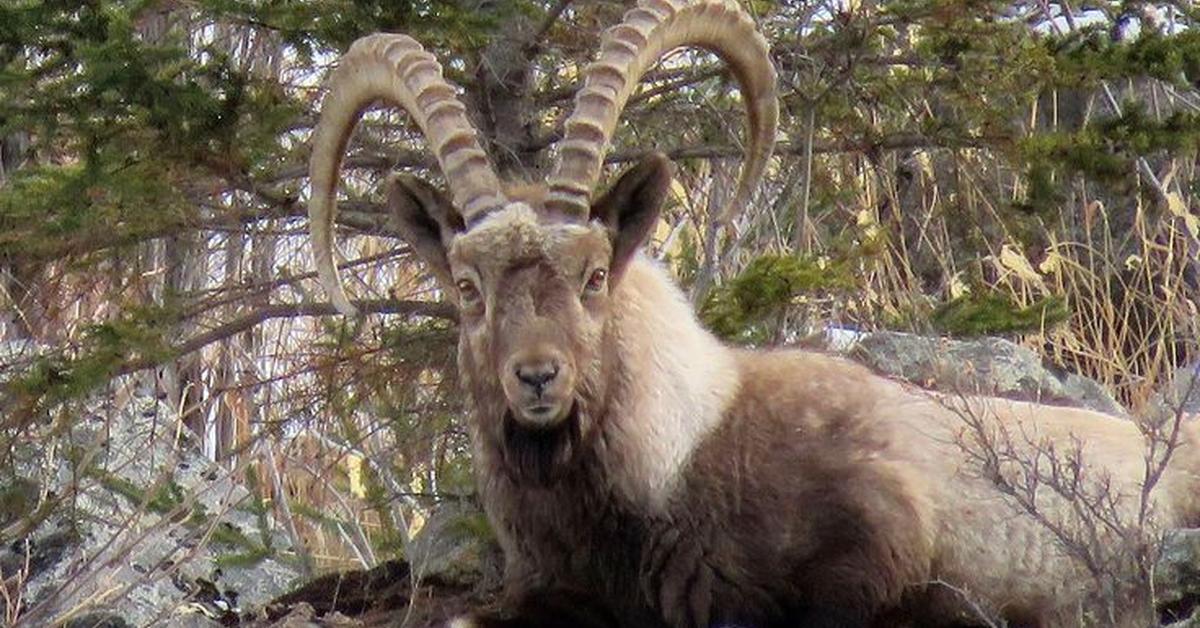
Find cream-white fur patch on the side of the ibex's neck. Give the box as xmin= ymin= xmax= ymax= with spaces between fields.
xmin=601 ymin=256 xmax=738 ymax=510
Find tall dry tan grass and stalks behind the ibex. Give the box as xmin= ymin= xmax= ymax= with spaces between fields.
xmin=0 ymin=2 xmax=1200 ymax=624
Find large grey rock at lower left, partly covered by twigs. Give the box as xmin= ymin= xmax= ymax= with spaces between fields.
xmin=8 ymin=374 xmax=300 ymax=628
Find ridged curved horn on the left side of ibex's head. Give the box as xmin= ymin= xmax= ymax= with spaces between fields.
xmin=308 ymin=35 xmax=504 ymax=316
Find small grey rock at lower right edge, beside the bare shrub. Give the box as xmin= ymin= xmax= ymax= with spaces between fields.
xmin=1154 ymin=528 xmax=1200 ymax=628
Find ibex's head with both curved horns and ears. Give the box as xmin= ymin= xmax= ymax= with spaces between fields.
xmin=310 ymin=0 xmax=778 ymax=456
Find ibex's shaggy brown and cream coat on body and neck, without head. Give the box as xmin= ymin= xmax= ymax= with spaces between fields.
xmin=463 ymin=253 xmax=1200 ymax=627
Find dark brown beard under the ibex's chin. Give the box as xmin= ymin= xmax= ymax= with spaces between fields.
xmin=503 ymin=402 xmax=583 ymax=486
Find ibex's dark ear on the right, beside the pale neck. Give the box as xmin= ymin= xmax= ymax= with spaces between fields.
xmin=592 ymin=152 xmax=674 ymax=280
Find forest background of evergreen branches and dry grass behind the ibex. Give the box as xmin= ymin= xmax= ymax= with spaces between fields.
xmin=0 ymin=0 xmax=1200 ymax=624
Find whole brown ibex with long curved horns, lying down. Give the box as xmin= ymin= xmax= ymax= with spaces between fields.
xmin=310 ymin=0 xmax=1200 ymax=628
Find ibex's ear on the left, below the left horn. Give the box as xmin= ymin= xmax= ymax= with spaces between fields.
xmin=388 ymin=174 xmax=464 ymax=289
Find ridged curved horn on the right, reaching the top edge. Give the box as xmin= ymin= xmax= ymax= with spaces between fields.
xmin=546 ymin=0 xmax=779 ymax=222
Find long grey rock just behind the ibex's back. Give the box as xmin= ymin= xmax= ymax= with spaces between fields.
xmin=823 ymin=330 xmax=1127 ymax=415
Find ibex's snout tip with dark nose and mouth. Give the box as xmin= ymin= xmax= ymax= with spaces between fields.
xmin=504 ymin=347 xmax=575 ymax=429
